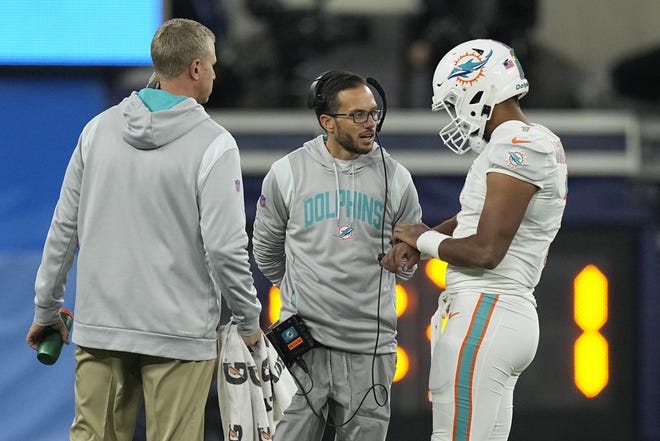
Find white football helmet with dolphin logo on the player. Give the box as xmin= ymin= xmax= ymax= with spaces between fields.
xmin=431 ymin=40 xmax=529 ymax=155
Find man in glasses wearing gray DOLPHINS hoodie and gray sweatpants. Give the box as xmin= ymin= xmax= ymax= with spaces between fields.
xmin=253 ymin=71 xmax=421 ymax=441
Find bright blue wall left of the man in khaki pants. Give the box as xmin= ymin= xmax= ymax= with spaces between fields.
xmin=0 ymin=78 xmax=105 ymax=441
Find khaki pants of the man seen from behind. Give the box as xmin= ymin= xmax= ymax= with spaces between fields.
xmin=71 ymin=346 xmax=215 ymax=441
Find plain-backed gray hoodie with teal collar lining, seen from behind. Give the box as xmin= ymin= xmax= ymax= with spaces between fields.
xmin=35 ymin=89 xmax=261 ymax=360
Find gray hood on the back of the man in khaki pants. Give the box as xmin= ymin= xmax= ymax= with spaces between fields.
xmin=119 ymin=91 xmax=210 ymax=150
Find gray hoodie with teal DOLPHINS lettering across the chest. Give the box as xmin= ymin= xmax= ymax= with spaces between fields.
xmin=253 ymin=136 xmax=421 ymax=354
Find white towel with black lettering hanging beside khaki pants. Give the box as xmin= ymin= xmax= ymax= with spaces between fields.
xmin=217 ymin=322 xmax=297 ymax=441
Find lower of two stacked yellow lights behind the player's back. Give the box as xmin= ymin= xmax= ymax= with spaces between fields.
xmin=574 ymin=331 xmax=609 ymax=398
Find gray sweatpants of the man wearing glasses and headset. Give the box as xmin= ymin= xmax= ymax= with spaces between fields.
xmin=273 ymin=347 xmax=396 ymax=441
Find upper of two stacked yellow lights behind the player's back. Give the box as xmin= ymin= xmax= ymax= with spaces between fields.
xmin=573 ymin=265 xmax=608 ymax=331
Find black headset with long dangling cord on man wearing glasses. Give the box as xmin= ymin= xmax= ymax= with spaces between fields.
xmin=288 ymin=71 xmax=389 ymax=427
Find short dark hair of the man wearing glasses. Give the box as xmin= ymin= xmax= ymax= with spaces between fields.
xmin=310 ymin=70 xmax=367 ymax=119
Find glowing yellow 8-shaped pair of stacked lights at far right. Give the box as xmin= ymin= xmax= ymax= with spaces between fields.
xmin=573 ymin=265 xmax=609 ymax=398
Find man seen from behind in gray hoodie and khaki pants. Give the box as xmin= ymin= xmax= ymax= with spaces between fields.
xmin=27 ymin=19 xmax=261 ymax=441
